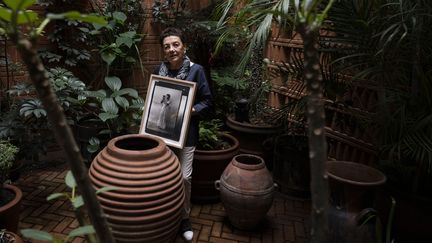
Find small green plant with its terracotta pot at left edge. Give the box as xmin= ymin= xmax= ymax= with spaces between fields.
xmin=0 ymin=140 xmax=22 ymax=232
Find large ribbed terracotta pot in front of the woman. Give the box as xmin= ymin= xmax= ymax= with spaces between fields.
xmin=89 ymin=134 xmax=184 ymax=242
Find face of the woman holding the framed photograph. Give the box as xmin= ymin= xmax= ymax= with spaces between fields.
xmin=162 ymin=36 xmax=186 ymax=69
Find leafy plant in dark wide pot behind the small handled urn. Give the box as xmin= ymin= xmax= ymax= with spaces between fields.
xmin=212 ymin=58 xmax=281 ymax=163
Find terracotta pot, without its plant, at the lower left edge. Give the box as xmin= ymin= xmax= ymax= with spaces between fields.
xmin=0 ymin=184 xmax=22 ymax=233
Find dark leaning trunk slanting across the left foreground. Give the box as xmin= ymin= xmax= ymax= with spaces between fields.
xmin=12 ymin=37 xmax=115 ymax=243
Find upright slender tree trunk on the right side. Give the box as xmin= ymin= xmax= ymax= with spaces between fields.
xmin=300 ymin=26 xmax=328 ymax=242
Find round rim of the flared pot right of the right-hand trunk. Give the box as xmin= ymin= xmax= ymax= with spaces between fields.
xmin=326 ymin=161 xmax=387 ymax=186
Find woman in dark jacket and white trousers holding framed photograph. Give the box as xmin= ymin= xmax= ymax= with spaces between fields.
xmin=154 ymin=27 xmax=212 ymax=241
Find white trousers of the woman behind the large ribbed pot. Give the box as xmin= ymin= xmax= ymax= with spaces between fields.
xmin=172 ymin=146 xmax=195 ymax=219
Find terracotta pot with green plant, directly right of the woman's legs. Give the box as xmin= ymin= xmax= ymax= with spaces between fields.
xmin=191 ymin=119 xmax=239 ymax=203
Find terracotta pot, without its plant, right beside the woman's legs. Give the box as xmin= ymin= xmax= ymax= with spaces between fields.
xmin=191 ymin=134 xmax=239 ymax=203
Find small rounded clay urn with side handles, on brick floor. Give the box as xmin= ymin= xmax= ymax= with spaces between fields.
xmin=215 ymin=154 xmax=274 ymax=230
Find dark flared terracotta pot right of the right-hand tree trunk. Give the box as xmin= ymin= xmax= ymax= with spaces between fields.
xmin=327 ymin=161 xmax=386 ymax=243
